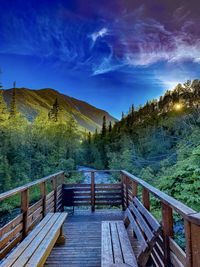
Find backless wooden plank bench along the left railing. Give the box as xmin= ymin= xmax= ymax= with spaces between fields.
xmin=1 ymin=212 xmax=67 ymax=267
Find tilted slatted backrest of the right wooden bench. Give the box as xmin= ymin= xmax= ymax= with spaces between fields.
xmin=124 ymin=197 xmax=161 ymax=266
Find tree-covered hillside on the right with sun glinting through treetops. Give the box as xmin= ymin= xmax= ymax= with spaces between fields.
xmin=82 ymin=80 xmax=200 ymax=210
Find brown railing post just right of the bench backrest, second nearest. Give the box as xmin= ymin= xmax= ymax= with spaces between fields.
xmin=162 ymin=203 xmax=173 ymax=267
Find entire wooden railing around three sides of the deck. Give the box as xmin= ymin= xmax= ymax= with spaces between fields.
xmin=0 ymin=170 xmax=200 ymax=267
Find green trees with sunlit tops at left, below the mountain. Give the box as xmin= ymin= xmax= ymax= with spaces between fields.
xmin=0 ymin=88 xmax=80 ymax=192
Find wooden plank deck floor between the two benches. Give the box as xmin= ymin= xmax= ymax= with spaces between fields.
xmin=45 ymin=209 xmax=123 ymax=267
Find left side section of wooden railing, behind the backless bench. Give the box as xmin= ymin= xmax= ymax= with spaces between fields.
xmin=0 ymin=171 xmax=64 ymax=259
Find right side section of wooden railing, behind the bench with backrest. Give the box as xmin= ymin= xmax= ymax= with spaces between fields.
xmin=121 ymin=171 xmax=200 ymax=267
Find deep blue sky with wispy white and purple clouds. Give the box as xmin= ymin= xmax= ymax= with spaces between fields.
xmin=0 ymin=0 xmax=200 ymax=118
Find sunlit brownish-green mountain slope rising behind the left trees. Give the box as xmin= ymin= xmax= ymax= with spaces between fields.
xmin=3 ymin=88 xmax=116 ymax=132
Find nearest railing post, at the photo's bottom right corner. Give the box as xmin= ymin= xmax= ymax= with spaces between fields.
xmin=184 ymin=213 xmax=200 ymax=267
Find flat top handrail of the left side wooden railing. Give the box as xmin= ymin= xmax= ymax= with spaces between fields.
xmin=0 ymin=171 xmax=64 ymax=201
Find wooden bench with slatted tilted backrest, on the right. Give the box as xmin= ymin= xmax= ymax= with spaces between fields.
xmin=101 ymin=197 xmax=161 ymax=267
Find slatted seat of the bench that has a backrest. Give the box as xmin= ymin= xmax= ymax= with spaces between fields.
xmin=101 ymin=221 xmax=138 ymax=267
